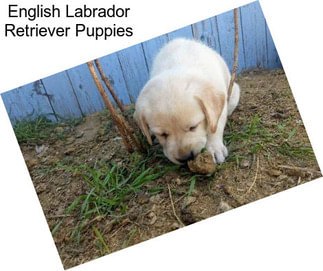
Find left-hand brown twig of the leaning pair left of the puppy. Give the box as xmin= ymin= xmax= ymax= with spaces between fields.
xmin=87 ymin=61 xmax=133 ymax=152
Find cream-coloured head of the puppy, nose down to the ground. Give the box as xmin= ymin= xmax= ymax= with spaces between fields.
xmin=134 ymin=75 xmax=225 ymax=164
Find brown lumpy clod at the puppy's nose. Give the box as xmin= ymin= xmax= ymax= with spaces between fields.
xmin=187 ymin=152 xmax=215 ymax=174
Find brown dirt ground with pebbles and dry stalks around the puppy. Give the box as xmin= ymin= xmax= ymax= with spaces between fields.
xmin=21 ymin=70 xmax=321 ymax=268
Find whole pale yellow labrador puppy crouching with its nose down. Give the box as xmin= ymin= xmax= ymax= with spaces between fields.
xmin=134 ymin=39 xmax=240 ymax=164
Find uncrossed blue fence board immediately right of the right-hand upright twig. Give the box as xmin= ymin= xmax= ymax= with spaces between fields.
xmin=240 ymin=2 xmax=268 ymax=68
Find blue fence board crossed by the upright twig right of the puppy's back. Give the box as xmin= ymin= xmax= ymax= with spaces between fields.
xmin=217 ymin=10 xmax=246 ymax=73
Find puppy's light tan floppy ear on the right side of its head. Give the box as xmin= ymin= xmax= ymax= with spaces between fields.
xmin=195 ymin=87 xmax=225 ymax=133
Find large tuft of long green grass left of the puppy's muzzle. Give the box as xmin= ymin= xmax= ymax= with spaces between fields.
xmin=52 ymin=154 xmax=178 ymax=241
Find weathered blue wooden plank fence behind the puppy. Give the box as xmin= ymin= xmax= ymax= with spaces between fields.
xmin=1 ymin=2 xmax=281 ymax=123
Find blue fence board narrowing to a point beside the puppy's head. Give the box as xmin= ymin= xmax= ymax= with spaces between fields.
xmin=117 ymin=44 xmax=148 ymax=102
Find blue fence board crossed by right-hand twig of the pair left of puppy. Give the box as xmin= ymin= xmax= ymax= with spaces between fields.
xmin=98 ymin=54 xmax=130 ymax=104
